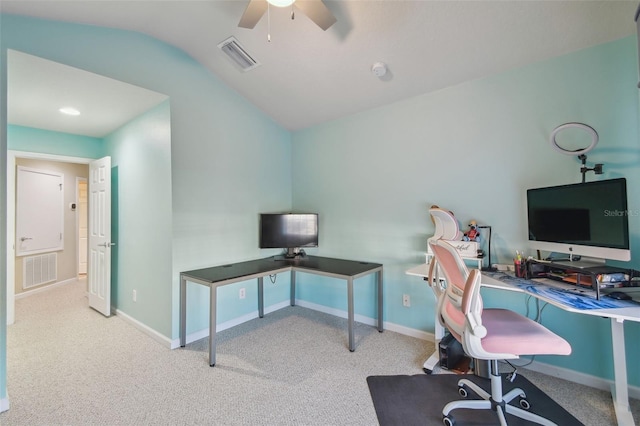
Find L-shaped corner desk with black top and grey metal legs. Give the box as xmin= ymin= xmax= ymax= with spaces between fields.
xmin=180 ymin=256 xmax=384 ymax=367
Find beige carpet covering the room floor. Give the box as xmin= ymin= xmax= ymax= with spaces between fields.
xmin=0 ymin=282 xmax=640 ymax=426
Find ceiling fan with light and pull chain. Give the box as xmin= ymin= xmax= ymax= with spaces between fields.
xmin=238 ymin=0 xmax=336 ymax=31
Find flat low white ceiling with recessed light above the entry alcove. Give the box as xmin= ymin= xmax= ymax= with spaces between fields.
xmin=7 ymin=50 xmax=168 ymax=138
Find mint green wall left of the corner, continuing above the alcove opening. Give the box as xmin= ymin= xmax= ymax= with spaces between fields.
xmin=0 ymin=14 xmax=291 ymax=351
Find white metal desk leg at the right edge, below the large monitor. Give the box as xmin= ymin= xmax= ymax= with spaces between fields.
xmin=611 ymin=318 xmax=635 ymax=426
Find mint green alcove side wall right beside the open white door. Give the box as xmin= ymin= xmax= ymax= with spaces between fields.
xmin=104 ymin=100 xmax=172 ymax=336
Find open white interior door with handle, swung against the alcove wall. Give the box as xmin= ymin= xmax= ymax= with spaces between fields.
xmin=87 ymin=157 xmax=113 ymax=317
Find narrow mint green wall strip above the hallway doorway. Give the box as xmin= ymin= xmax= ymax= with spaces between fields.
xmin=7 ymin=124 xmax=104 ymax=158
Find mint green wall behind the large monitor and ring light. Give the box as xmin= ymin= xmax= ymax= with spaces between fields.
xmin=292 ymin=37 xmax=640 ymax=386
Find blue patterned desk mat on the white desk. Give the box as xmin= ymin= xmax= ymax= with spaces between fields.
xmin=482 ymin=272 xmax=640 ymax=310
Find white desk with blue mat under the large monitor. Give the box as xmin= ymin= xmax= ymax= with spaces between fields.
xmin=406 ymin=265 xmax=640 ymax=426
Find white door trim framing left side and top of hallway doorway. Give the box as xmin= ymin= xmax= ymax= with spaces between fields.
xmin=6 ymin=150 xmax=93 ymax=325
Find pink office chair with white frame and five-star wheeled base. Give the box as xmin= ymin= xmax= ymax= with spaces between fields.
xmin=429 ymin=240 xmax=571 ymax=426
